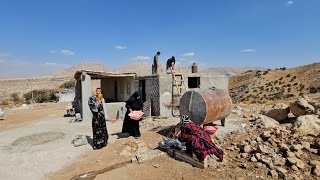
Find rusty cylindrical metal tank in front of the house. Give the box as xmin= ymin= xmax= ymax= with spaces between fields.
xmin=179 ymin=88 xmax=232 ymax=124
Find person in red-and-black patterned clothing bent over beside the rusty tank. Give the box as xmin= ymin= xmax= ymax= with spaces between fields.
xmin=179 ymin=115 xmax=223 ymax=161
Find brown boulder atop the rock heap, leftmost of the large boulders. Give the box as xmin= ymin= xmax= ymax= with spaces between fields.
xmin=262 ymin=103 xmax=290 ymax=121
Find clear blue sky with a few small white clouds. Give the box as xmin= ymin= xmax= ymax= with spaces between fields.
xmin=0 ymin=0 xmax=320 ymax=77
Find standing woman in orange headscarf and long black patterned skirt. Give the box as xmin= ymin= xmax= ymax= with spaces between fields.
xmin=88 ymin=88 xmax=109 ymax=149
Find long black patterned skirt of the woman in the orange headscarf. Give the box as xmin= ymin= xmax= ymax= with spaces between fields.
xmin=92 ymin=112 xmax=109 ymax=149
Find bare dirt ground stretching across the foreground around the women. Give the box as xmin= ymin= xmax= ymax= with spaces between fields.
xmin=0 ymin=103 xmax=320 ymax=180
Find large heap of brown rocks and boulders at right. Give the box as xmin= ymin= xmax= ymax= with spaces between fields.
xmin=227 ymin=98 xmax=320 ymax=179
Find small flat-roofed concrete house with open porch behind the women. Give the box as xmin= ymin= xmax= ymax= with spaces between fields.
xmin=74 ymin=70 xmax=228 ymax=120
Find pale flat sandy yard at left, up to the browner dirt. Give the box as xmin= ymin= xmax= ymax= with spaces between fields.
xmin=0 ymin=103 xmax=129 ymax=179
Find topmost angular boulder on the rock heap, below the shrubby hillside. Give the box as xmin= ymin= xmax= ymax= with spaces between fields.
xmin=290 ymin=98 xmax=315 ymax=117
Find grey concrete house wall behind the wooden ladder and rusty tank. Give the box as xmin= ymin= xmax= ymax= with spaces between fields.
xmin=159 ymin=73 xmax=229 ymax=117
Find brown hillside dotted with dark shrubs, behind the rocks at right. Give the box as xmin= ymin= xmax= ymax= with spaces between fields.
xmin=229 ymin=63 xmax=320 ymax=103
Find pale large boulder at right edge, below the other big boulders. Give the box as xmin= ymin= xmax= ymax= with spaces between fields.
xmin=292 ymin=115 xmax=320 ymax=135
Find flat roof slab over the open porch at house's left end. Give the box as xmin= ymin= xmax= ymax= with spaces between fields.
xmin=74 ymin=70 xmax=137 ymax=79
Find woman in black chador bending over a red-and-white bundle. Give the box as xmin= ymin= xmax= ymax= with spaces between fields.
xmin=122 ymin=91 xmax=143 ymax=139
